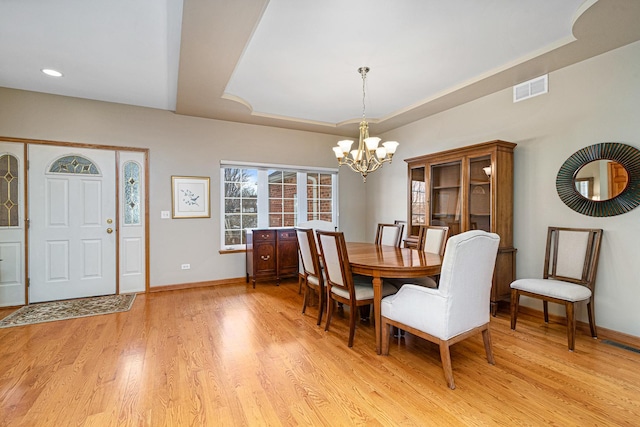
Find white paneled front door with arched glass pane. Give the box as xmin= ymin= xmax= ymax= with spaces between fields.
xmin=28 ymin=145 xmax=116 ymax=303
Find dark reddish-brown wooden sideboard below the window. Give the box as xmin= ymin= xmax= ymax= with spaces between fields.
xmin=246 ymin=228 xmax=298 ymax=288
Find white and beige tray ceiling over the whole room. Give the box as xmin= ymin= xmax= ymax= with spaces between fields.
xmin=0 ymin=0 xmax=640 ymax=135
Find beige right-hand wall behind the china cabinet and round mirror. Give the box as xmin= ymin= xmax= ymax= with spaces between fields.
xmin=367 ymin=42 xmax=640 ymax=336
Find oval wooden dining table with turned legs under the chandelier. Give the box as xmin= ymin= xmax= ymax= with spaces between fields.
xmin=347 ymin=242 xmax=442 ymax=354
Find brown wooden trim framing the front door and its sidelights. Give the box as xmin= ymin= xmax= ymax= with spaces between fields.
xmin=0 ymin=136 xmax=150 ymax=304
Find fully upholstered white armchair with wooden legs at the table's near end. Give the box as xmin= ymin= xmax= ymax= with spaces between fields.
xmin=381 ymin=230 xmax=500 ymax=389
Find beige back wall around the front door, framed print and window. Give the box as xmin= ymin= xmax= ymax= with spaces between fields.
xmin=0 ymin=88 xmax=365 ymax=287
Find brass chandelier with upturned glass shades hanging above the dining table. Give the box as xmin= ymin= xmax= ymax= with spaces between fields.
xmin=333 ymin=67 xmax=399 ymax=182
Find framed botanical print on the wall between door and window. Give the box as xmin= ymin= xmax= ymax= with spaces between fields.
xmin=171 ymin=176 xmax=211 ymax=218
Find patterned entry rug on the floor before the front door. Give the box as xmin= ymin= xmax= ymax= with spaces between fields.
xmin=0 ymin=294 xmax=136 ymax=328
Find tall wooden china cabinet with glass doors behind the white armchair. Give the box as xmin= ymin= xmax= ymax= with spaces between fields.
xmin=405 ymin=141 xmax=516 ymax=315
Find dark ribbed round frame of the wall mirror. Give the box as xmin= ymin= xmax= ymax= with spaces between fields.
xmin=556 ymin=142 xmax=640 ymax=217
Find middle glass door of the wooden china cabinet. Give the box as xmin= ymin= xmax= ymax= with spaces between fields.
xmin=429 ymin=161 xmax=461 ymax=236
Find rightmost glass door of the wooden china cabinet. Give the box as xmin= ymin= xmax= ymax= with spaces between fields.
xmin=468 ymin=155 xmax=492 ymax=232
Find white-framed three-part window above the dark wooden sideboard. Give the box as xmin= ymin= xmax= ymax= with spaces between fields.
xmin=220 ymin=162 xmax=338 ymax=250
